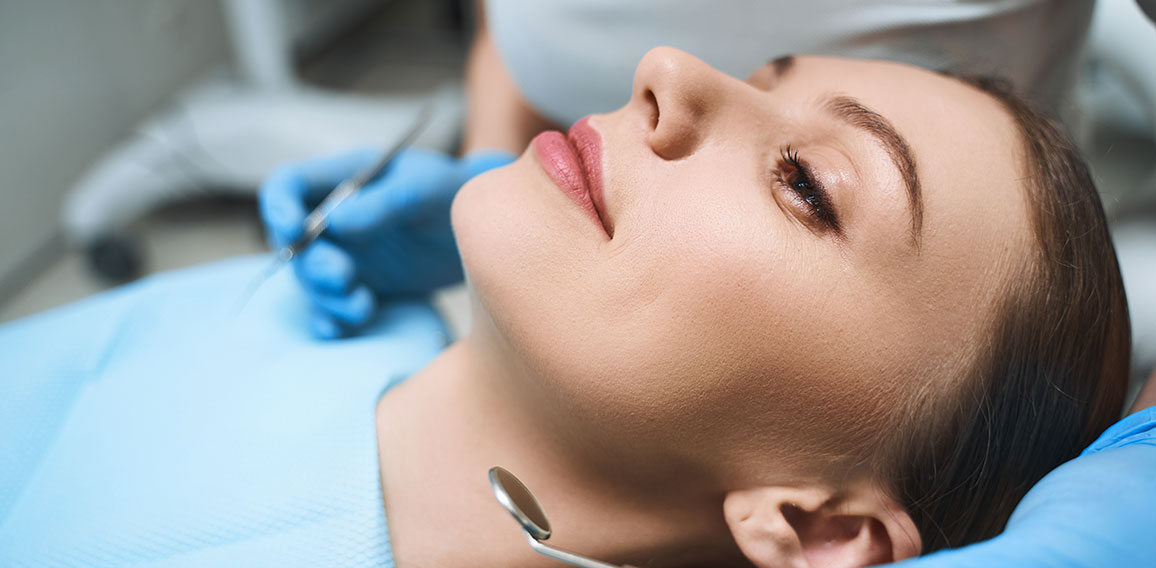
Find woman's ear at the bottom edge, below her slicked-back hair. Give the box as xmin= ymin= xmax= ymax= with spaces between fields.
xmin=723 ymin=484 xmax=922 ymax=568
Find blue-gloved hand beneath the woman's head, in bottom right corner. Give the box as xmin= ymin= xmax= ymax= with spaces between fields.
xmin=897 ymin=407 xmax=1156 ymax=568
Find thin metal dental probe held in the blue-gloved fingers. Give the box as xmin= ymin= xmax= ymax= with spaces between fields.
xmin=235 ymin=104 xmax=434 ymax=313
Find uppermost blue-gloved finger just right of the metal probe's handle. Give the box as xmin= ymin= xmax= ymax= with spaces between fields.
xmin=327 ymin=148 xmax=460 ymax=239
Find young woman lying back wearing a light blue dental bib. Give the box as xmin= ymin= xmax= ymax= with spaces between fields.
xmin=0 ymin=49 xmax=1129 ymax=567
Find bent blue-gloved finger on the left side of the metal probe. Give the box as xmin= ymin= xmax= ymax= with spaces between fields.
xmin=258 ymin=148 xmax=377 ymax=246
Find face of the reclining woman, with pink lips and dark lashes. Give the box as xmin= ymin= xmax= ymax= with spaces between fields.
xmin=453 ymin=49 xmax=1030 ymax=483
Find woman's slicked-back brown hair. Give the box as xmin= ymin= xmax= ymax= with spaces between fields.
xmin=895 ymin=76 xmax=1131 ymax=553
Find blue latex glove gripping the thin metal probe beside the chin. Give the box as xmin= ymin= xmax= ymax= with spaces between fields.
xmin=259 ymin=148 xmax=516 ymax=338
